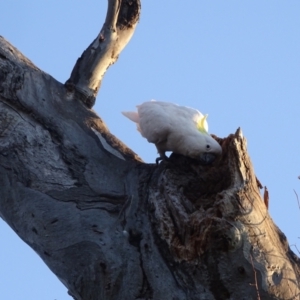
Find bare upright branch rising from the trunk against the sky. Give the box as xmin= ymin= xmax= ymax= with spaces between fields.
xmin=65 ymin=0 xmax=141 ymax=107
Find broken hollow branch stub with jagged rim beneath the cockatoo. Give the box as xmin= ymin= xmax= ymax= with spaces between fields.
xmin=148 ymin=129 xmax=300 ymax=299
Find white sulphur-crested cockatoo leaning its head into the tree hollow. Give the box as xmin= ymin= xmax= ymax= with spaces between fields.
xmin=122 ymin=100 xmax=222 ymax=164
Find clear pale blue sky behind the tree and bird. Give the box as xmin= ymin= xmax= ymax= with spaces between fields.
xmin=0 ymin=0 xmax=300 ymax=300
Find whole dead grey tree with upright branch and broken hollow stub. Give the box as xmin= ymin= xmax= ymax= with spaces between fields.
xmin=0 ymin=0 xmax=300 ymax=300
